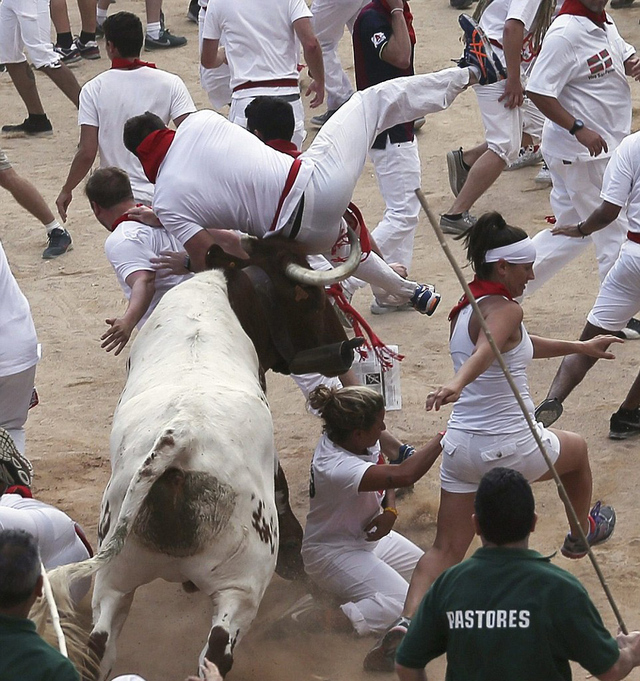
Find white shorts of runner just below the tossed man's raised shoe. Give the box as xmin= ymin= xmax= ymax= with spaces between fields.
xmin=473 ymin=80 xmax=523 ymax=164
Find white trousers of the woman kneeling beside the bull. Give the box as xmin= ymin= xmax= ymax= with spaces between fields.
xmin=308 ymin=531 xmax=424 ymax=636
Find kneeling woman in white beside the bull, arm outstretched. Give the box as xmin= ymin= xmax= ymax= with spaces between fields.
xmin=302 ymin=386 xmax=440 ymax=635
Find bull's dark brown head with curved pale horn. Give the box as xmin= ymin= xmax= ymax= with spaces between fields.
xmin=207 ymin=234 xmax=362 ymax=376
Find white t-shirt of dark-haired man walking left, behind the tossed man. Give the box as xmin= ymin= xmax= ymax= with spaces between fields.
xmin=78 ymin=66 xmax=196 ymax=205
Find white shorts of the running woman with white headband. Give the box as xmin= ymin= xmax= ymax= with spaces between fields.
xmin=440 ymin=423 xmax=560 ymax=494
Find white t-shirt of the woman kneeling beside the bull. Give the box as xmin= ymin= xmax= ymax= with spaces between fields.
xmin=302 ymin=434 xmax=385 ymax=566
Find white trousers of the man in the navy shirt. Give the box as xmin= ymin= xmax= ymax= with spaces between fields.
xmin=369 ymin=139 xmax=421 ymax=269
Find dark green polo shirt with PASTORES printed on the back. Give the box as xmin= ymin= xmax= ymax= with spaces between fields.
xmin=396 ymin=548 xmax=620 ymax=681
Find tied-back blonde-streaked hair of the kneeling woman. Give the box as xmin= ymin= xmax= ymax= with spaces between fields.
xmin=309 ymin=385 xmax=384 ymax=444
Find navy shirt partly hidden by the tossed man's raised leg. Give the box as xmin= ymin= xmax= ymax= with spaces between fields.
xmin=353 ymin=0 xmax=414 ymax=149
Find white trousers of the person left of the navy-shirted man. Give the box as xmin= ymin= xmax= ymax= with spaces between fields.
xmin=311 ymin=0 xmax=367 ymax=109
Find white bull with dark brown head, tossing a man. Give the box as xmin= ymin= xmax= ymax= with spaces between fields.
xmin=46 ymin=231 xmax=360 ymax=678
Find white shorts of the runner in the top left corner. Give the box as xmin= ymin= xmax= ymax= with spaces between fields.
xmin=0 ymin=0 xmax=60 ymax=69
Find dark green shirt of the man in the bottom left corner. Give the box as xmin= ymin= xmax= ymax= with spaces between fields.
xmin=0 ymin=615 xmax=80 ymax=681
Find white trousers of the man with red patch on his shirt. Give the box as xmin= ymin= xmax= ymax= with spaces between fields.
xmin=525 ymin=155 xmax=629 ymax=296
